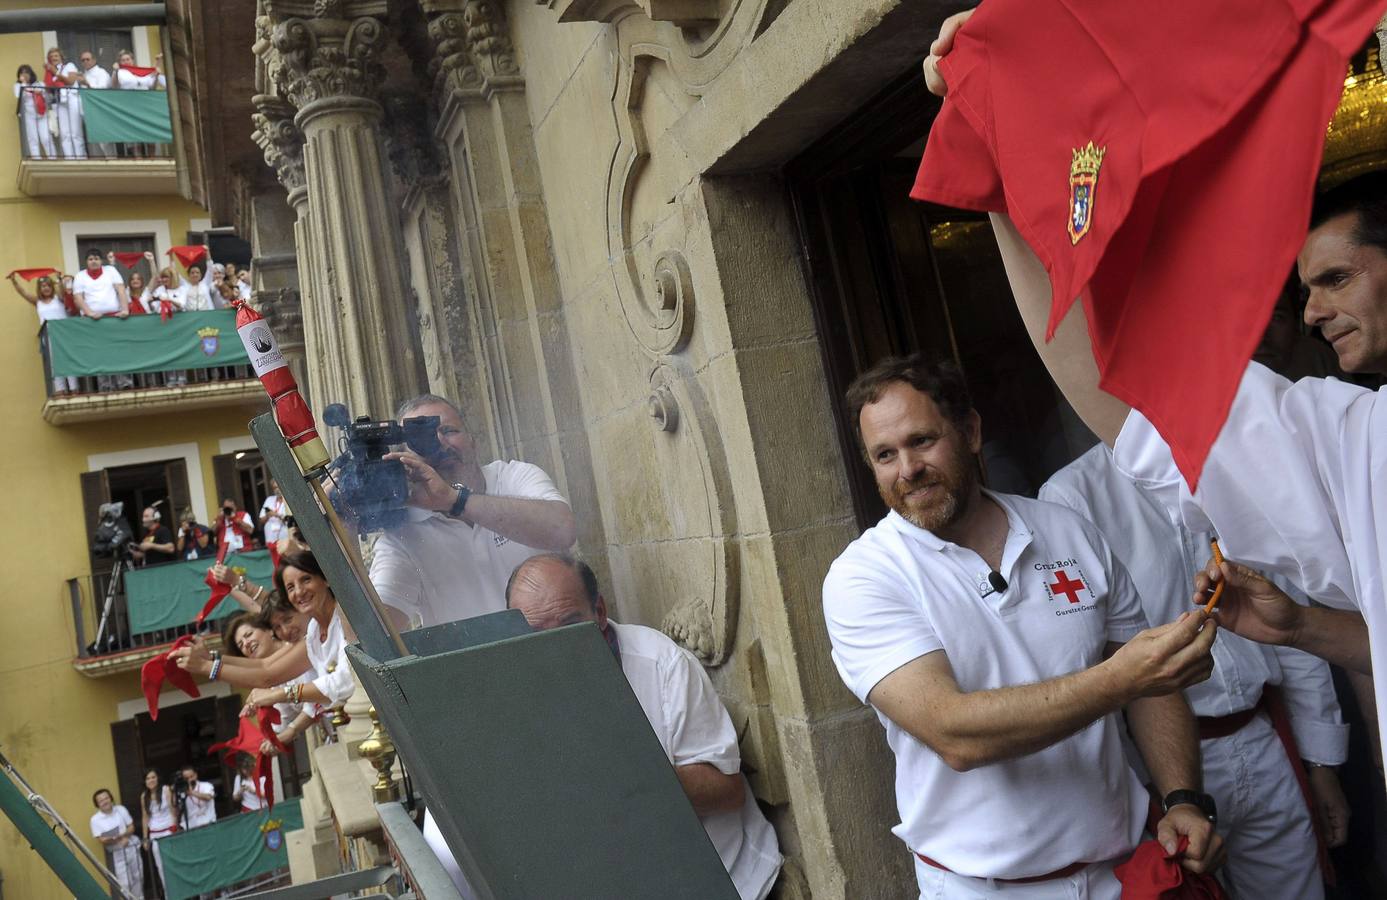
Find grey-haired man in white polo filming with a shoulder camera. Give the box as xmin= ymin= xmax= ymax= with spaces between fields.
xmin=370 ymin=394 xmax=577 ymax=628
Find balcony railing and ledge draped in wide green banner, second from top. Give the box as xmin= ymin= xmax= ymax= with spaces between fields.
xmin=39 ymin=309 xmax=265 ymax=424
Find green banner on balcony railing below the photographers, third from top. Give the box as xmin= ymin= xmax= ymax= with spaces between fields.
xmin=125 ymin=551 xmax=273 ymax=634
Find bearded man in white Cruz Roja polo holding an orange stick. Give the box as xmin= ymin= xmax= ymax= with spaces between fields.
xmin=824 ymin=356 xmax=1222 ymax=900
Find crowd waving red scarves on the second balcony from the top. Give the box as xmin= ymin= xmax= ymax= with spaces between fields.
xmin=10 ymin=244 xmax=251 ymax=397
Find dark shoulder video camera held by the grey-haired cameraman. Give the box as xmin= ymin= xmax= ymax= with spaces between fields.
xmin=323 ymin=404 xmax=442 ymax=531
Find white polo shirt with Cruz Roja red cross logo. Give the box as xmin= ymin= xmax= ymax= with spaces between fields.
xmin=824 ymin=492 xmax=1148 ymax=878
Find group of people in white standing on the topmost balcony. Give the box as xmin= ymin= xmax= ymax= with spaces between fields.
xmin=14 ymin=47 xmax=166 ymax=159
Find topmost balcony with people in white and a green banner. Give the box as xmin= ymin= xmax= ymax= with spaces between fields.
xmin=14 ymin=47 xmax=179 ymax=197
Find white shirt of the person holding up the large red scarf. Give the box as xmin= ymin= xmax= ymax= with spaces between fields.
xmin=1112 ymin=362 xmax=1387 ymax=759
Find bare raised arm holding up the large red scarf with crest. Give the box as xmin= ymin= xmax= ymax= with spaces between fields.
xmin=992 ymin=212 xmax=1130 ymax=447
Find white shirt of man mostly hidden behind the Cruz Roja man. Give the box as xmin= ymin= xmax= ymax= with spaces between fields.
xmin=1040 ymin=444 xmax=1348 ymax=765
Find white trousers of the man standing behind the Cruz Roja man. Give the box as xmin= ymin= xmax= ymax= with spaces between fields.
xmin=1200 ymin=713 xmax=1325 ymax=900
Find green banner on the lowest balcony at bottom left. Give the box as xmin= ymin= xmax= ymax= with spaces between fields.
xmin=160 ymin=797 xmax=304 ymax=900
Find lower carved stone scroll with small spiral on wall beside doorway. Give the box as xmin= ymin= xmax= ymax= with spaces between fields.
xmin=646 ymin=363 xmax=741 ymax=666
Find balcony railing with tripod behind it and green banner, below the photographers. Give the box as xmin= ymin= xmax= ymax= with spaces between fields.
xmin=67 ymin=551 xmax=270 ymax=675
